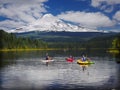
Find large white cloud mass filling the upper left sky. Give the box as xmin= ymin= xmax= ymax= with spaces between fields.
xmin=0 ymin=0 xmax=48 ymax=31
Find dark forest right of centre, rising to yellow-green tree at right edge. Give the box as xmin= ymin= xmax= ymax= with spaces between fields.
xmin=49 ymin=33 xmax=120 ymax=50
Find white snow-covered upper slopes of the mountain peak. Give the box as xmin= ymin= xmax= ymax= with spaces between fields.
xmin=10 ymin=14 xmax=98 ymax=33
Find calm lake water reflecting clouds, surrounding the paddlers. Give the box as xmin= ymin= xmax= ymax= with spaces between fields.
xmin=0 ymin=51 xmax=120 ymax=90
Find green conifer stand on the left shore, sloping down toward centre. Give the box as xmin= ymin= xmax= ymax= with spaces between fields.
xmin=0 ymin=30 xmax=47 ymax=49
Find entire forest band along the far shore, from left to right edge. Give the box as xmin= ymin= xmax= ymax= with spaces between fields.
xmin=0 ymin=30 xmax=120 ymax=52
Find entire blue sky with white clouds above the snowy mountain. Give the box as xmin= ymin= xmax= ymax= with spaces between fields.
xmin=0 ymin=0 xmax=120 ymax=31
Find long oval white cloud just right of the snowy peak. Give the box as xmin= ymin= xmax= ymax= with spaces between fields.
xmin=58 ymin=11 xmax=115 ymax=28
